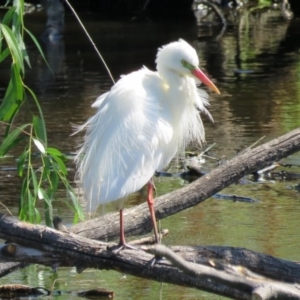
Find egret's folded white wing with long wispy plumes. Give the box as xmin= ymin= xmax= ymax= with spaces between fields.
xmin=77 ymin=69 xmax=176 ymax=210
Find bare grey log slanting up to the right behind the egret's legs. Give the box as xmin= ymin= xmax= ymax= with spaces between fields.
xmin=69 ymin=128 xmax=300 ymax=241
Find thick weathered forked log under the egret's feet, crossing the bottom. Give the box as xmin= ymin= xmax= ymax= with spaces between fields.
xmin=0 ymin=214 xmax=300 ymax=299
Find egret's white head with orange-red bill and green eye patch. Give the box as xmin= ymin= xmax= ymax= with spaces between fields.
xmin=156 ymin=39 xmax=220 ymax=94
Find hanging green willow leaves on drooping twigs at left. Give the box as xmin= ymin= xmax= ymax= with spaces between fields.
xmin=0 ymin=0 xmax=83 ymax=226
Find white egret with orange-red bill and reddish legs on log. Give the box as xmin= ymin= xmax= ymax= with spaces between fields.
xmin=76 ymin=39 xmax=220 ymax=246
